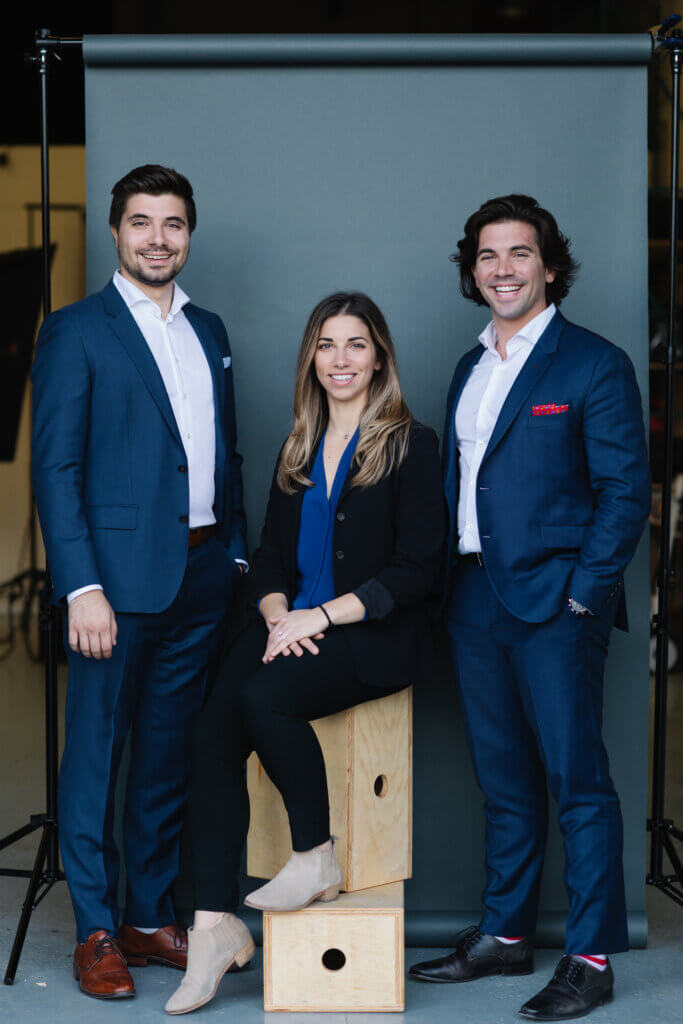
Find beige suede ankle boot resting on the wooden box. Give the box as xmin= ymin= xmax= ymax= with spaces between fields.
xmin=245 ymin=843 xmax=342 ymax=910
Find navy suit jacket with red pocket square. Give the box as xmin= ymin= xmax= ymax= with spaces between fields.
xmin=443 ymin=312 xmax=650 ymax=629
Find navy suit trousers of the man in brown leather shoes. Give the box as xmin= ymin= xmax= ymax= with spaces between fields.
xmin=59 ymin=539 xmax=239 ymax=942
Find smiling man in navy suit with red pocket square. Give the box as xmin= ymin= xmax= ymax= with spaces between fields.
xmin=411 ymin=196 xmax=650 ymax=1020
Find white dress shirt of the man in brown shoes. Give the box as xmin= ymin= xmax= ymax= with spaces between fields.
xmin=68 ymin=270 xmax=216 ymax=603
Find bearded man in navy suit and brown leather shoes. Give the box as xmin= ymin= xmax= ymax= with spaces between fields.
xmin=33 ymin=165 xmax=247 ymax=998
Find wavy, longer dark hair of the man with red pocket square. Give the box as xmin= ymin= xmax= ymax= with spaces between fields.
xmin=452 ymin=196 xmax=579 ymax=306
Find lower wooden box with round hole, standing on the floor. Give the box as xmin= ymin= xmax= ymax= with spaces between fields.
xmin=263 ymin=882 xmax=405 ymax=1013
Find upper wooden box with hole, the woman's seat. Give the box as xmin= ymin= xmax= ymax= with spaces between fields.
xmin=247 ymin=692 xmax=413 ymax=892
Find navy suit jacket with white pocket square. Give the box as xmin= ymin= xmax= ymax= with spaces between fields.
xmin=32 ymin=282 xmax=247 ymax=612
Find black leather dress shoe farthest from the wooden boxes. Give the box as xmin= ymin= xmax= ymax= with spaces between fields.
xmin=519 ymin=955 xmax=614 ymax=1021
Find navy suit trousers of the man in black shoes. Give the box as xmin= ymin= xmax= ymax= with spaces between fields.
xmin=446 ymin=563 xmax=628 ymax=953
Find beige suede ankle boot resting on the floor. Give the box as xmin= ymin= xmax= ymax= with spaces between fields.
xmin=166 ymin=913 xmax=256 ymax=1014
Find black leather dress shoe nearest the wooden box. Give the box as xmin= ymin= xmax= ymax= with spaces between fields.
xmin=409 ymin=928 xmax=533 ymax=982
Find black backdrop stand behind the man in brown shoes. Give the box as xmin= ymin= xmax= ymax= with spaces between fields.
xmin=0 ymin=29 xmax=81 ymax=985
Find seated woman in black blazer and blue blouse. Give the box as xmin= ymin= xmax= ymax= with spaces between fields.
xmin=166 ymin=293 xmax=445 ymax=1013
